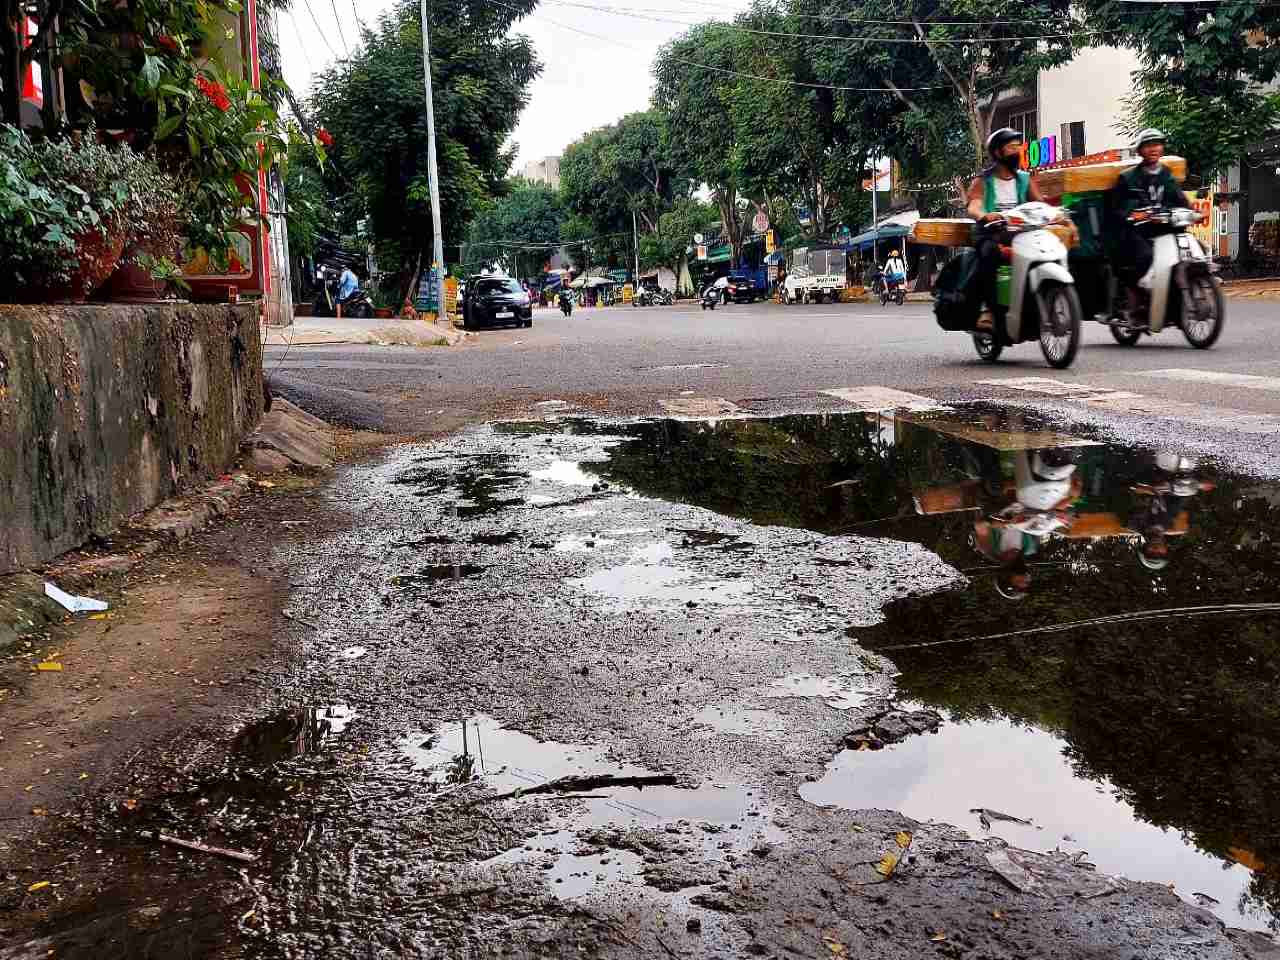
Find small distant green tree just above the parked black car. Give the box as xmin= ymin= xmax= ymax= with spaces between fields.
xmin=465 ymin=179 xmax=566 ymax=276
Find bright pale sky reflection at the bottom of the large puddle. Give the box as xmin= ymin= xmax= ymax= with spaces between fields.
xmin=800 ymin=721 xmax=1266 ymax=928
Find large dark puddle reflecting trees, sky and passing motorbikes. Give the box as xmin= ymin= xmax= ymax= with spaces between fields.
xmin=514 ymin=407 xmax=1280 ymax=929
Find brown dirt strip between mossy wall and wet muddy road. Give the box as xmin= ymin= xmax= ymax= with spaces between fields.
xmin=0 ymin=431 xmax=394 ymax=956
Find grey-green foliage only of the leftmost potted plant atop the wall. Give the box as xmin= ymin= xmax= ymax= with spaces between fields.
xmin=0 ymin=124 xmax=160 ymax=289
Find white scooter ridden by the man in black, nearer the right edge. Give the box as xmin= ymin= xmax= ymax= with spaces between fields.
xmin=1094 ymin=206 xmax=1226 ymax=349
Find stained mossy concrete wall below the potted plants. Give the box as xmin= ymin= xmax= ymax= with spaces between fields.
xmin=0 ymin=303 xmax=262 ymax=573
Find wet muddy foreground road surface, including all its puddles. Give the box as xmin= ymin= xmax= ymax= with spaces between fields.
xmin=10 ymin=404 xmax=1280 ymax=959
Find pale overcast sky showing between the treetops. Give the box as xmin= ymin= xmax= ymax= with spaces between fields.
xmin=279 ymin=0 xmax=745 ymax=173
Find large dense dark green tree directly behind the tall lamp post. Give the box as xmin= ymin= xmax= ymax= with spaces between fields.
xmin=311 ymin=0 xmax=541 ymax=292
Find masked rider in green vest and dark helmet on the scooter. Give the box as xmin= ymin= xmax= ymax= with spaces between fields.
xmin=966 ymin=127 xmax=1044 ymax=330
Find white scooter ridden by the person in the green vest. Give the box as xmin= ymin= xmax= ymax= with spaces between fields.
xmin=973 ymin=201 xmax=1084 ymax=370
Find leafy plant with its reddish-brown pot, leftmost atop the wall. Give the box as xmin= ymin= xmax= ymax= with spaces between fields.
xmin=0 ymin=125 xmax=154 ymax=302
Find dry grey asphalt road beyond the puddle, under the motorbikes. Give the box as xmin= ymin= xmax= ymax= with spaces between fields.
xmin=268 ymin=300 xmax=1280 ymax=433
